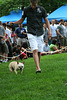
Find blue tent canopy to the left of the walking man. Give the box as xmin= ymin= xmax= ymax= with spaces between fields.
xmin=0 ymin=10 xmax=27 ymax=24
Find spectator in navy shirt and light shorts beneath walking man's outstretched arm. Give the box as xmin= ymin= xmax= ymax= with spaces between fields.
xmin=15 ymin=24 xmax=27 ymax=46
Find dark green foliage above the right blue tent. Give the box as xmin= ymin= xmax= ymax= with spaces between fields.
xmin=40 ymin=0 xmax=67 ymax=13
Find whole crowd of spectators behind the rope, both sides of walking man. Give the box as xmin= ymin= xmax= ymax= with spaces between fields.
xmin=0 ymin=19 xmax=67 ymax=62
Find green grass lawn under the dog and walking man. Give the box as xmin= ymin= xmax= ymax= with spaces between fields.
xmin=0 ymin=53 xmax=67 ymax=100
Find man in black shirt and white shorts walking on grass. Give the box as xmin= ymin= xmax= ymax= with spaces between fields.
xmin=10 ymin=0 xmax=51 ymax=73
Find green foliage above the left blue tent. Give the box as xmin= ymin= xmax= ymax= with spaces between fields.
xmin=0 ymin=0 xmax=29 ymax=16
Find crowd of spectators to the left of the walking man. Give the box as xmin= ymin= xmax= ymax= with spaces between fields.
xmin=0 ymin=21 xmax=33 ymax=62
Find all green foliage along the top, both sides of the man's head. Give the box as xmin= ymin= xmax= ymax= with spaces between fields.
xmin=0 ymin=0 xmax=67 ymax=16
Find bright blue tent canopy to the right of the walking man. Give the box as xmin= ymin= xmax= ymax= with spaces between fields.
xmin=47 ymin=4 xmax=67 ymax=21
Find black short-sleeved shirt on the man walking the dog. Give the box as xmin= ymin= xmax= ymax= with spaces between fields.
xmin=22 ymin=5 xmax=47 ymax=36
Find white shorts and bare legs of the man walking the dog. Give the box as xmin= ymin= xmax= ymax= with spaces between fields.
xmin=28 ymin=34 xmax=43 ymax=72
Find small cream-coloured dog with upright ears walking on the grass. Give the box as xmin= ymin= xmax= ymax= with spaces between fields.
xmin=9 ymin=61 xmax=25 ymax=74
